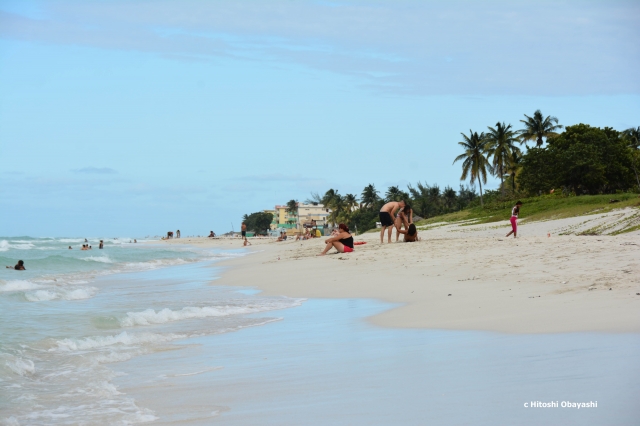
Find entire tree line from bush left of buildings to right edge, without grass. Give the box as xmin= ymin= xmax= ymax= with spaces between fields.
xmin=244 ymin=110 xmax=640 ymax=232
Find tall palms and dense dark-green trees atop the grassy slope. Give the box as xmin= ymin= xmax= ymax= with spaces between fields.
xmin=453 ymin=110 xmax=640 ymax=205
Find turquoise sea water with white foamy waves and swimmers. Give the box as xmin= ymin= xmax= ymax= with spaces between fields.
xmin=0 ymin=237 xmax=302 ymax=425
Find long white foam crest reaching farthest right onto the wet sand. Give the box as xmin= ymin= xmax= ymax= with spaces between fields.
xmin=120 ymin=299 xmax=303 ymax=327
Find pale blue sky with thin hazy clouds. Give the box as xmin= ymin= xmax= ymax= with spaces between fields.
xmin=0 ymin=0 xmax=640 ymax=238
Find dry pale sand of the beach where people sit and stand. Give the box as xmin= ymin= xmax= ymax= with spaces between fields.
xmin=162 ymin=211 xmax=640 ymax=334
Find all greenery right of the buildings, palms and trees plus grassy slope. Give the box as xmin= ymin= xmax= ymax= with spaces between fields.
xmin=302 ymin=110 xmax=640 ymax=236
